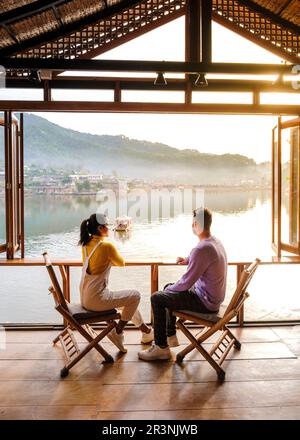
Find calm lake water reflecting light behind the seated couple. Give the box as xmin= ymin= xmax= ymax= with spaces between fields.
xmin=0 ymin=190 xmax=300 ymax=323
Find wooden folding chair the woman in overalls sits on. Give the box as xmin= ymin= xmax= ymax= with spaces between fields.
xmin=43 ymin=252 xmax=120 ymax=378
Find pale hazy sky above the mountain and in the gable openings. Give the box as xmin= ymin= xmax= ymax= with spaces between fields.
xmin=29 ymin=18 xmax=296 ymax=162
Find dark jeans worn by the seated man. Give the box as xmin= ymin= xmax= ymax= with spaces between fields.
xmin=151 ymin=283 xmax=212 ymax=347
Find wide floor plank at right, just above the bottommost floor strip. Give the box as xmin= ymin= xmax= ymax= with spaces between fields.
xmin=97 ymin=380 xmax=300 ymax=411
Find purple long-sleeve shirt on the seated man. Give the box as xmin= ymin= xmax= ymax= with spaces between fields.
xmin=167 ymin=236 xmax=227 ymax=311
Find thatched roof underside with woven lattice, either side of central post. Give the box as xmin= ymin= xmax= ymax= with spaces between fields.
xmin=0 ymin=0 xmax=300 ymax=61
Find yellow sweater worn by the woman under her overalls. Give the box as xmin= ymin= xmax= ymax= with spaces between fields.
xmin=82 ymin=235 xmax=125 ymax=275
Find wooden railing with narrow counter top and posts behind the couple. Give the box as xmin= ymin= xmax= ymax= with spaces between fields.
xmin=0 ymin=256 xmax=300 ymax=327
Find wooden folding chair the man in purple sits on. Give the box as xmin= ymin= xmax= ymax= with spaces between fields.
xmin=172 ymin=258 xmax=260 ymax=381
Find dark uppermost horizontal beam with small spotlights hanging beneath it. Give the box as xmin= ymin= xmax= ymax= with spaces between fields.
xmin=0 ymin=58 xmax=293 ymax=75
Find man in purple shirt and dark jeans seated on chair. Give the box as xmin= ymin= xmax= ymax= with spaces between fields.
xmin=139 ymin=208 xmax=227 ymax=361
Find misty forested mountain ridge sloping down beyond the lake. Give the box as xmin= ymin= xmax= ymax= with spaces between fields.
xmin=1 ymin=114 xmax=266 ymax=183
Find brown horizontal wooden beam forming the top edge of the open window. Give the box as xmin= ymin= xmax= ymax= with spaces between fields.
xmin=0 ymin=101 xmax=300 ymax=115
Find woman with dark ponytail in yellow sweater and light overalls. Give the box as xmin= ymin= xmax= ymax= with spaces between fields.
xmin=79 ymin=214 xmax=153 ymax=353
